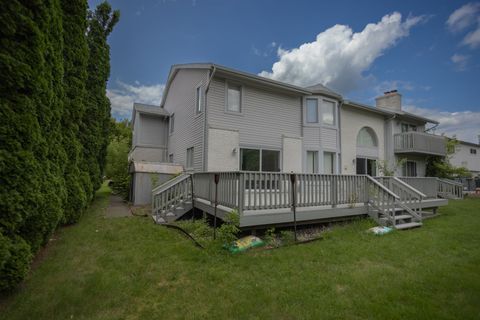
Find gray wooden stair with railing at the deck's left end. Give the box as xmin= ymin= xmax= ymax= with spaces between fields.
xmin=152 ymin=173 xmax=193 ymax=224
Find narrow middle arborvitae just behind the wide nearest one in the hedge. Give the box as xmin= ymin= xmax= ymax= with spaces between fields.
xmin=62 ymin=0 xmax=92 ymax=223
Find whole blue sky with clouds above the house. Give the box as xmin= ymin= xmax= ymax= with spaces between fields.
xmin=89 ymin=0 xmax=480 ymax=142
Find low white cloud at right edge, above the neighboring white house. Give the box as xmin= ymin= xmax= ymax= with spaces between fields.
xmin=403 ymin=105 xmax=480 ymax=143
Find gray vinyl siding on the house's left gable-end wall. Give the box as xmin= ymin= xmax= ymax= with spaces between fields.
xmin=164 ymin=69 xmax=208 ymax=171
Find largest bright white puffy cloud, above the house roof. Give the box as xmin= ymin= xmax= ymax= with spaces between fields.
xmin=260 ymin=12 xmax=428 ymax=93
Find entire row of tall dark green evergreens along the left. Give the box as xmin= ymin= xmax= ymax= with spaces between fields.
xmin=0 ymin=0 xmax=119 ymax=291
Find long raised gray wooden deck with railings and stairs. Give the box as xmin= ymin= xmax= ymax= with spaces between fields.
xmin=152 ymin=172 xmax=462 ymax=228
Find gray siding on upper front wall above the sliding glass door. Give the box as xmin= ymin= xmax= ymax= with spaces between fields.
xmin=207 ymin=78 xmax=301 ymax=150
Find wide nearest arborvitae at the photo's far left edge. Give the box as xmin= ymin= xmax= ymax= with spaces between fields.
xmin=0 ymin=0 xmax=65 ymax=290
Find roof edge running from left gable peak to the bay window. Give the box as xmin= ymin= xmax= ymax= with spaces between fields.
xmin=160 ymin=62 xmax=312 ymax=108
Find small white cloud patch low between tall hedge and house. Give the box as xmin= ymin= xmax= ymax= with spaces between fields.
xmin=107 ymin=81 xmax=165 ymax=118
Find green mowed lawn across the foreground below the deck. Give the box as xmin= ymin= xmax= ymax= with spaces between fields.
xmin=0 ymin=188 xmax=480 ymax=319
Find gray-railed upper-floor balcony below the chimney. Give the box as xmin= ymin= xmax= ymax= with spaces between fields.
xmin=394 ymin=131 xmax=447 ymax=156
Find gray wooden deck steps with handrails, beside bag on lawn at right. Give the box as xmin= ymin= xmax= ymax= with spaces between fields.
xmin=368 ymin=177 xmax=426 ymax=230
